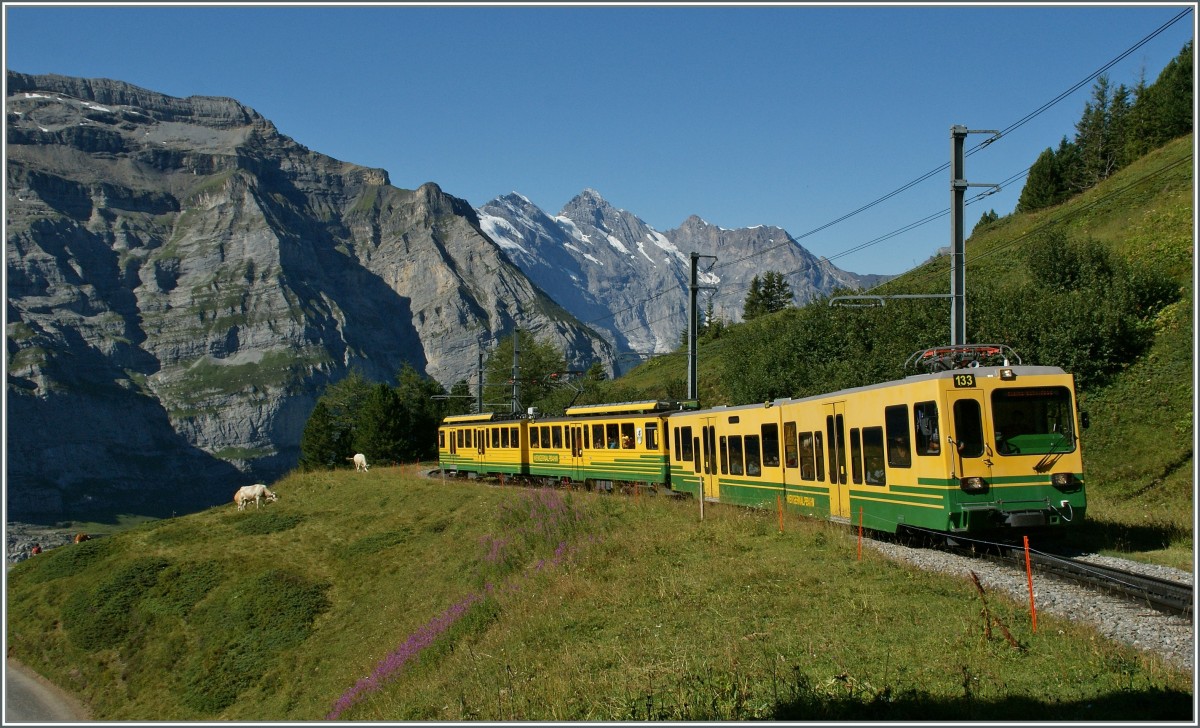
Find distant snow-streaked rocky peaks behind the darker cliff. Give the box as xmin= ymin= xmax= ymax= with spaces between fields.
xmin=479 ymin=189 xmax=887 ymax=366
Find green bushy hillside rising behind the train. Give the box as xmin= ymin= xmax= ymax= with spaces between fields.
xmin=588 ymin=134 xmax=1195 ymax=570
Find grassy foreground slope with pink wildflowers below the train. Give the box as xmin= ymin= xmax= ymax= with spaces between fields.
xmin=7 ymin=468 xmax=1193 ymax=721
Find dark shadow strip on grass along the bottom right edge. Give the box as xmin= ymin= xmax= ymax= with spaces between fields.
xmin=769 ymin=690 xmax=1195 ymax=722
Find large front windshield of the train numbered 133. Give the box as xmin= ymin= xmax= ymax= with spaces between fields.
xmin=991 ymin=386 xmax=1075 ymax=455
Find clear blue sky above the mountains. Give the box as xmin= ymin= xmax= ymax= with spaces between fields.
xmin=5 ymin=2 xmax=1195 ymax=273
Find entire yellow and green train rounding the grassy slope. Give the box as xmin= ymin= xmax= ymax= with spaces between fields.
xmin=438 ymin=345 xmax=1087 ymax=534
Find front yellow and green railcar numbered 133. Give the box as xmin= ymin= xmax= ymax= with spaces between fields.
xmin=668 ymin=347 xmax=1087 ymax=534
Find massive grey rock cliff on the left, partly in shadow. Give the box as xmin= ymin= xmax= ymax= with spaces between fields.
xmin=5 ymin=72 xmax=613 ymax=519
